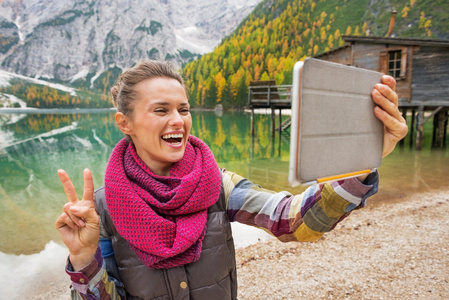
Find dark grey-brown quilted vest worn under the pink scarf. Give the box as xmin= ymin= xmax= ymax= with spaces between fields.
xmin=95 ymin=183 xmax=237 ymax=300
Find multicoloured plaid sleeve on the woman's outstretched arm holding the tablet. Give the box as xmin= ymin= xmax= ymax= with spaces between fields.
xmin=223 ymin=170 xmax=379 ymax=242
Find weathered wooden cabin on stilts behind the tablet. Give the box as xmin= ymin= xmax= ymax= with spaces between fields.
xmin=315 ymin=36 xmax=449 ymax=150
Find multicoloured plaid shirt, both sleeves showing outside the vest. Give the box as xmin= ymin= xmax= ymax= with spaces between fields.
xmin=66 ymin=170 xmax=379 ymax=300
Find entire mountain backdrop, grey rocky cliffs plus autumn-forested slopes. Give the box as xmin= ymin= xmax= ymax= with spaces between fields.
xmin=0 ymin=0 xmax=449 ymax=108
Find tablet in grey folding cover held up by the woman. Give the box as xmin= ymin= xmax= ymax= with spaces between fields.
xmin=289 ymin=58 xmax=383 ymax=186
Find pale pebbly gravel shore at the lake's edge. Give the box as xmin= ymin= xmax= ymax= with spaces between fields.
xmin=21 ymin=190 xmax=449 ymax=300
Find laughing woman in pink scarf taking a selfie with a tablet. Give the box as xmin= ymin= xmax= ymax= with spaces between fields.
xmin=56 ymin=60 xmax=407 ymax=299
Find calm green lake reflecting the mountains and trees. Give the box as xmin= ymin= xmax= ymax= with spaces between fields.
xmin=0 ymin=111 xmax=449 ymax=294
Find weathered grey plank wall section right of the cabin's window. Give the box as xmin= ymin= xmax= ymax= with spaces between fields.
xmin=411 ymin=46 xmax=449 ymax=103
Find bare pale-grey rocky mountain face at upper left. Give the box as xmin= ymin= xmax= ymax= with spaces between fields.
xmin=0 ymin=0 xmax=260 ymax=86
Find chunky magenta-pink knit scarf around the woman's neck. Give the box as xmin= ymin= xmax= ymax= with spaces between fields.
xmin=105 ymin=136 xmax=221 ymax=269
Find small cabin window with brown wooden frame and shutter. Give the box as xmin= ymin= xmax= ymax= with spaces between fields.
xmin=379 ymin=47 xmax=407 ymax=79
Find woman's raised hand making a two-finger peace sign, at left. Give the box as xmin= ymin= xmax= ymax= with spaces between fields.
xmin=55 ymin=169 xmax=100 ymax=271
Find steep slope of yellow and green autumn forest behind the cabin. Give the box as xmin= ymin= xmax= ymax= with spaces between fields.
xmin=183 ymin=0 xmax=449 ymax=108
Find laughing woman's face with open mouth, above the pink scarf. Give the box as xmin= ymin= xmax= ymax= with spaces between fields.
xmin=116 ymin=77 xmax=192 ymax=176
